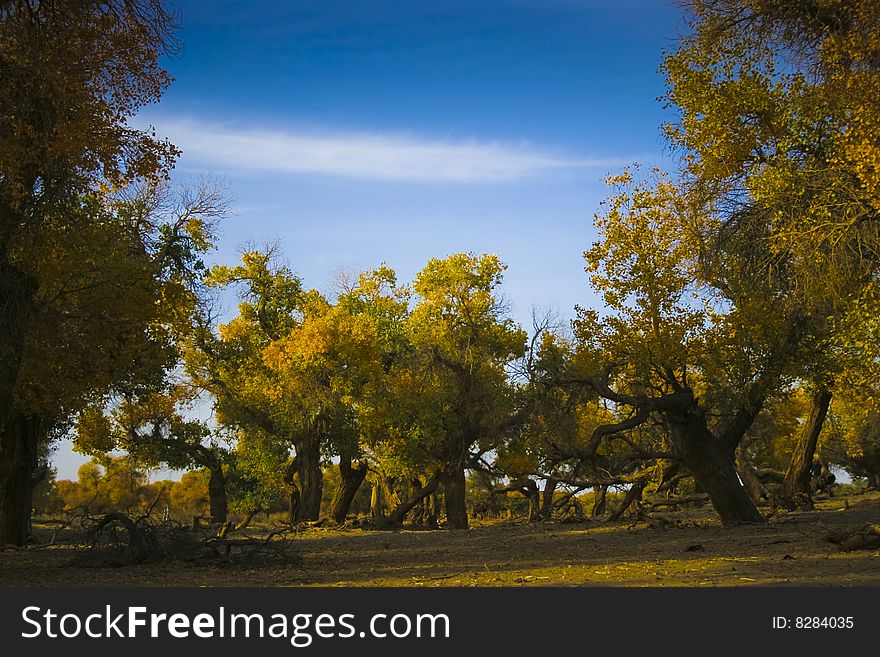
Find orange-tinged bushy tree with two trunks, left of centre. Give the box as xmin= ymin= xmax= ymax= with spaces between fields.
xmin=195 ymin=251 xmax=420 ymax=522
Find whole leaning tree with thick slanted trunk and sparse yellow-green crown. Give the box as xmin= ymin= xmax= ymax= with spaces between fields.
xmin=549 ymin=172 xmax=824 ymax=523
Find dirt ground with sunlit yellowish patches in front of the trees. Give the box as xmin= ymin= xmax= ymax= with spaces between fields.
xmin=0 ymin=492 xmax=880 ymax=587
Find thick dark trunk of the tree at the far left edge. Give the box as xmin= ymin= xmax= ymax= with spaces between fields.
xmin=0 ymin=411 xmax=40 ymax=546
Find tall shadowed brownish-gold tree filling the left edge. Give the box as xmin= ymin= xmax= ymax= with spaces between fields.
xmin=0 ymin=0 xmax=192 ymax=544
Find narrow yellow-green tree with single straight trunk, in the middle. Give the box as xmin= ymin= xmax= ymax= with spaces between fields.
xmin=396 ymin=253 xmax=526 ymax=529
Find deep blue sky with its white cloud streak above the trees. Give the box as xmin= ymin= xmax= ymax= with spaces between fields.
xmin=55 ymin=0 xmax=683 ymax=478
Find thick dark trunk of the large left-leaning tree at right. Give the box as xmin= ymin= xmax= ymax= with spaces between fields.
xmin=666 ymin=403 xmax=764 ymax=525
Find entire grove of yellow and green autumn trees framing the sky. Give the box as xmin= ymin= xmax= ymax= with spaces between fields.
xmin=0 ymin=0 xmax=880 ymax=545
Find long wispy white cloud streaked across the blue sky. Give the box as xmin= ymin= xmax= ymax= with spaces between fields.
xmin=150 ymin=119 xmax=631 ymax=183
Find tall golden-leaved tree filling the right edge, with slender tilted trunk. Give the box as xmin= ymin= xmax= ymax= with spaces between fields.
xmin=664 ymin=0 xmax=880 ymax=510
